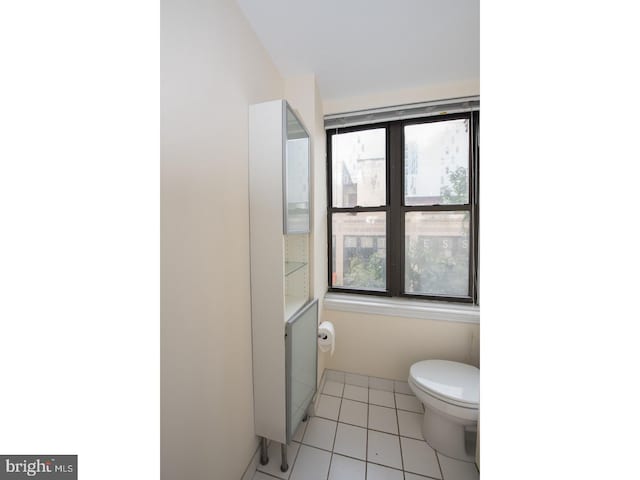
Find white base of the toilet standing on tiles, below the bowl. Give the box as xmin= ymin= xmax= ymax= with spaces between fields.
xmin=422 ymin=408 xmax=477 ymax=462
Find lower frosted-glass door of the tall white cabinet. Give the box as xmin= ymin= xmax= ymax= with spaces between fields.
xmin=285 ymin=300 xmax=318 ymax=443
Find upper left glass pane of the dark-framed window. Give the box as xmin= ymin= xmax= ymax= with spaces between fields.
xmin=331 ymin=128 xmax=387 ymax=207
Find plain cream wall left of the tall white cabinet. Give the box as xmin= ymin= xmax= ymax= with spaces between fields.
xmin=160 ymin=0 xmax=284 ymax=480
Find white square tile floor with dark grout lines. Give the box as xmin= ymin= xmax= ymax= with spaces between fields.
xmin=253 ymin=370 xmax=479 ymax=480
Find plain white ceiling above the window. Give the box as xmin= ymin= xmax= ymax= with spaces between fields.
xmin=237 ymin=0 xmax=480 ymax=100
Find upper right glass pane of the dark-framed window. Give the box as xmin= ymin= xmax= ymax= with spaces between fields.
xmin=404 ymin=119 xmax=469 ymax=205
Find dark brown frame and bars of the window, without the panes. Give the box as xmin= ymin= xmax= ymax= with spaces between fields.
xmin=327 ymin=111 xmax=480 ymax=305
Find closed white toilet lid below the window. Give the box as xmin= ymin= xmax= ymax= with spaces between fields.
xmin=410 ymin=360 xmax=480 ymax=406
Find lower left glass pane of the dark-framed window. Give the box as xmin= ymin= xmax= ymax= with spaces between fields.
xmin=331 ymin=212 xmax=387 ymax=290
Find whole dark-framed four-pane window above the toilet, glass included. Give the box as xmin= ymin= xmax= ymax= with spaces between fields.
xmin=327 ymin=111 xmax=480 ymax=303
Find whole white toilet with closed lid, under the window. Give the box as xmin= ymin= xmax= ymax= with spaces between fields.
xmin=409 ymin=360 xmax=480 ymax=462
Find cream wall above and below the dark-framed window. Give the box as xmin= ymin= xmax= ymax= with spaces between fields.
xmin=316 ymin=81 xmax=480 ymax=380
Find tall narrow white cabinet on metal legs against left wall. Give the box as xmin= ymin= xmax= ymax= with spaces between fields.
xmin=249 ymin=100 xmax=318 ymax=471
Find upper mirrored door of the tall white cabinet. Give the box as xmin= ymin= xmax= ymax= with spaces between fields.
xmin=283 ymin=102 xmax=310 ymax=234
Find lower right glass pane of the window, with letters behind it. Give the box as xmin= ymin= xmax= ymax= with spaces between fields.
xmin=404 ymin=212 xmax=471 ymax=297
